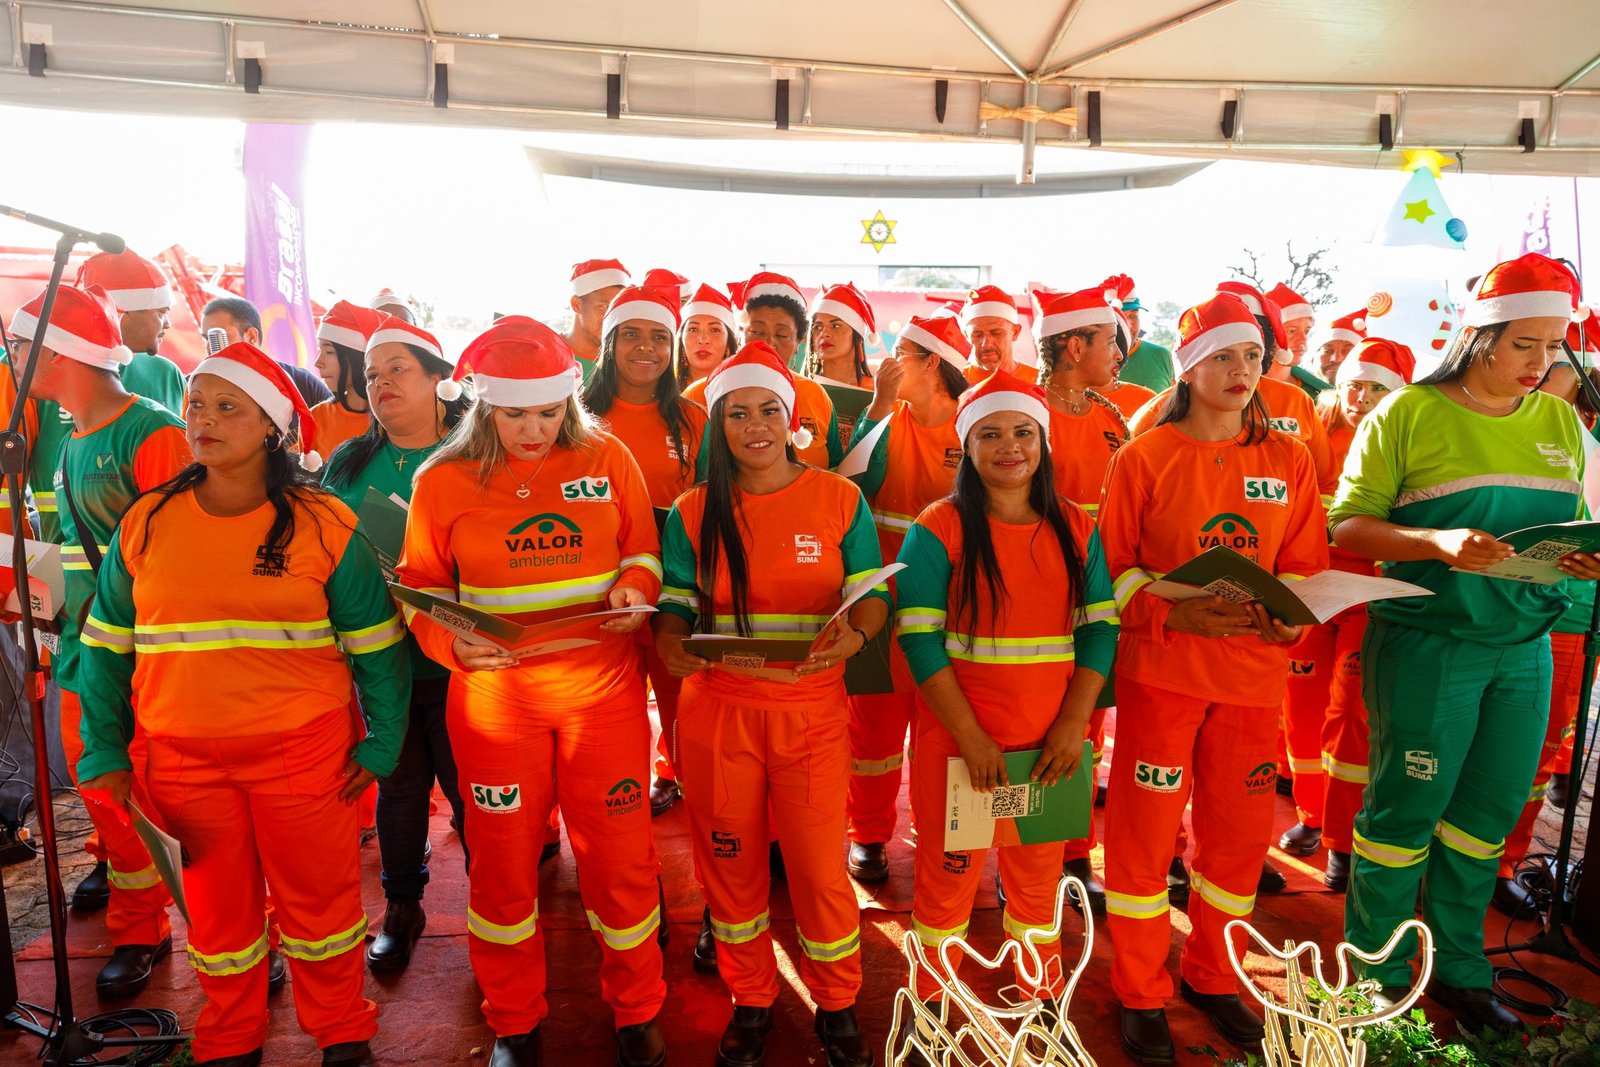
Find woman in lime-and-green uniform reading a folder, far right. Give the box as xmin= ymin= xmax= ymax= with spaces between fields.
xmin=1330 ymin=253 xmax=1600 ymax=1030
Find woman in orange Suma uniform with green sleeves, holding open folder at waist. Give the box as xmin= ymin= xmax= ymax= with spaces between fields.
xmin=656 ymin=342 xmax=888 ymax=1067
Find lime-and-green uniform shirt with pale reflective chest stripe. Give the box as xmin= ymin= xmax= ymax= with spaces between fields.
xmin=1328 ymin=386 xmax=1592 ymax=645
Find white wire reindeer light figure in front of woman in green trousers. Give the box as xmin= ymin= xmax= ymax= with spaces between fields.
xmin=1226 ymin=918 xmax=1434 ymax=1067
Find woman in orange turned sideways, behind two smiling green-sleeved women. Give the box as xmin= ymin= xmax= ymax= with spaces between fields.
xmin=846 ymin=312 xmax=971 ymax=881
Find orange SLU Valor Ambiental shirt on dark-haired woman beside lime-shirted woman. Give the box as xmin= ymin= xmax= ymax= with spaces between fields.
xmin=1099 ymin=424 xmax=1328 ymax=707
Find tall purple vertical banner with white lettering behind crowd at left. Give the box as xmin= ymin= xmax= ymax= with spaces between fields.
xmin=245 ymin=122 xmax=317 ymax=366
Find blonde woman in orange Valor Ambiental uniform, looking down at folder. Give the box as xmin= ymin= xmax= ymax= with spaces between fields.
xmin=406 ymin=315 xmax=666 ymax=1067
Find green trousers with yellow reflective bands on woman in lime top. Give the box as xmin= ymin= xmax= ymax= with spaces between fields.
xmin=1344 ymin=619 xmax=1550 ymax=989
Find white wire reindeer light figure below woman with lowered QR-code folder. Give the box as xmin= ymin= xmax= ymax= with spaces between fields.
xmin=885 ymin=877 xmax=1096 ymax=1067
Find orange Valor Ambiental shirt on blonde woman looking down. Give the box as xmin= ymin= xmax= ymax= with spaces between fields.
xmin=395 ymin=430 xmax=661 ymax=710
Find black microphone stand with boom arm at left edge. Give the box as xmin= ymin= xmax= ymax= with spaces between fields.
xmin=0 ymin=217 xmax=189 ymax=1067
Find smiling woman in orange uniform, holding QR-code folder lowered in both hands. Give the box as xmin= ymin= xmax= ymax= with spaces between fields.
xmin=894 ymin=374 xmax=1117 ymax=1036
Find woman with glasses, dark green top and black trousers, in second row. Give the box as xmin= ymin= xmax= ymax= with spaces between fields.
xmin=312 ymin=315 xmax=469 ymax=974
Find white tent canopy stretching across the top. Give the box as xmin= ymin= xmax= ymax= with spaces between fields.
xmin=0 ymin=0 xmax=1600 ymax=181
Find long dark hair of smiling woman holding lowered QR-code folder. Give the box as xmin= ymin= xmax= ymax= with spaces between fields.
xmin=946 ymin=445 xmax=1088 ymax=651
